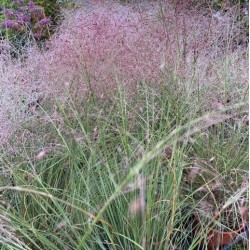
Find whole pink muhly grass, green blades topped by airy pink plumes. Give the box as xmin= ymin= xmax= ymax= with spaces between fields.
xmin=0 ymin=0 xmax=248 ymax=250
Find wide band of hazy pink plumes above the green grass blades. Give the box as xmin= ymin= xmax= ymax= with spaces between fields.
xmin=30 ymin=3 xmax=245 ymax=99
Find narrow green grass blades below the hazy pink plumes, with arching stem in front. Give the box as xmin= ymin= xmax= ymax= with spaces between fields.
xmin=1 ymin=79 xmax=247 ymax=249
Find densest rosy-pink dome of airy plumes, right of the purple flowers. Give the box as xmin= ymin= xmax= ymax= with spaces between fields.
xmin=36 ymin=3 xmax=169 ymax=95
